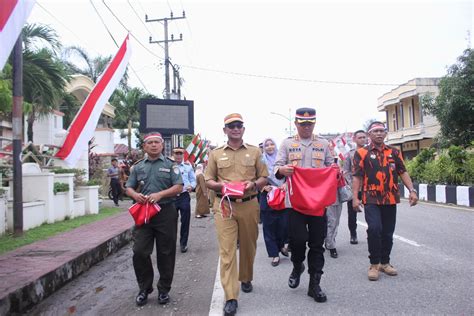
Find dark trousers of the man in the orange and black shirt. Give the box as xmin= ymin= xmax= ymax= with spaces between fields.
xmin=365 ymin=204 xmax=397 ymax=264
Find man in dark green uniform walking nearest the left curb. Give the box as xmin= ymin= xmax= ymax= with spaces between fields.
xmin=127 ymin=133 xmax=183 ymax=306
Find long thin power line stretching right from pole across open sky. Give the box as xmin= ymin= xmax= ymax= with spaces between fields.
xmin=181 ymin=64 xmax=437 ymax=87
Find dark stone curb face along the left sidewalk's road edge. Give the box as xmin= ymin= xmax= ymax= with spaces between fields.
xmin=0 ymin=228 xmax=132 ymax=315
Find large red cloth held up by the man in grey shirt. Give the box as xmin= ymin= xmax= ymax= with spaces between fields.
xmin=288 ymin=167 xmax=339 ymax=216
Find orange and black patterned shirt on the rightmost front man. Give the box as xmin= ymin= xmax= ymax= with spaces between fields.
xmin=353 ymin=144 xmax=406 ymax=205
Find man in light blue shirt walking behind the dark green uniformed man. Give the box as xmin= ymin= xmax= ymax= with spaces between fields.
xmin=173 ymin=147 xmax=196 ymax=253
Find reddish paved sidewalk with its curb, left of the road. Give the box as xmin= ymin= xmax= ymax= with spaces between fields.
xmin=0 ymin=201 xmax=133 ymax=315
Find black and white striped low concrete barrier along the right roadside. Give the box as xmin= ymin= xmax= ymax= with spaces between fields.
xmin=399 ymin=183 xmax=474 ymax=207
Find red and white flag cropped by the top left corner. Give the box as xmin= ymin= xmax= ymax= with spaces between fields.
xmin=0 ymin=0 xmax=35 ymax=70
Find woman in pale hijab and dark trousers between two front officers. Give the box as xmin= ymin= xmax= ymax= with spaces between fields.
xmin=260 ymin=138 xmax=288 ymax=267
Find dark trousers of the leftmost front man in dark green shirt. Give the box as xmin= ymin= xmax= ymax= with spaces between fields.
xmin=133 ymin=203 xmax=178 ymax=292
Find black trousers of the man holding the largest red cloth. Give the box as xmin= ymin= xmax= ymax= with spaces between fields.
xmin=289 ymin=209 xmax=328 ymax=274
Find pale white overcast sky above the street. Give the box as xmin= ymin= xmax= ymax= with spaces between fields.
xmin=29 ymin=0 xmax=474 ymax=144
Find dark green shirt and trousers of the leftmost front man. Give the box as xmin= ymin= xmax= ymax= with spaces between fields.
xmin=127 ymin=154 xmax=183 ymax=293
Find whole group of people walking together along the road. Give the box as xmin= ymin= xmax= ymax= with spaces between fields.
xmin=118 ymin=108 xmax=418 ymax=315
